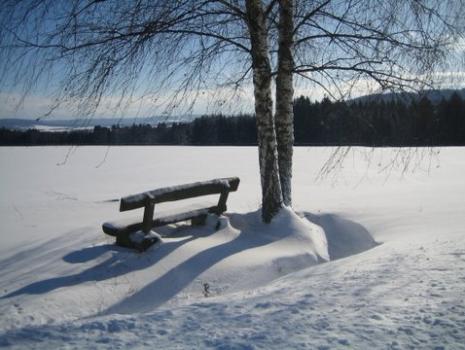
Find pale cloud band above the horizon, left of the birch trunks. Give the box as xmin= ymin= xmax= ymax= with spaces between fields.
xmin=0 ymin=88 xmax=253 ymax=119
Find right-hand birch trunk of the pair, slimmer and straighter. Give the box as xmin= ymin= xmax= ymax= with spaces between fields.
xmin=275 ymin=0 xmax=294 ymax=206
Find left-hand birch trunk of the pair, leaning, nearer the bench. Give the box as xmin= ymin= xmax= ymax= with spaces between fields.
xmin=246 ymin=0 xmax=283 ymax=222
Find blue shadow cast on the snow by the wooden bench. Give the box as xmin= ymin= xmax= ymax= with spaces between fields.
xmin=0 ymin=225 xmax=214 ymax=299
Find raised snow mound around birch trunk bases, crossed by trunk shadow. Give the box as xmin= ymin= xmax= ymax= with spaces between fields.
xmin=104 ymin=208 xmax=329 ymax=314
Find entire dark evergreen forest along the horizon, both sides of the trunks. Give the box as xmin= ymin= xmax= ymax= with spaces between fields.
xmin=0 ymin=93 xmax=465 ymax=146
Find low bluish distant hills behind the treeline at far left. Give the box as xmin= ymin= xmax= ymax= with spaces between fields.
xmin=0 ymin=115 xmax=197 ymax=131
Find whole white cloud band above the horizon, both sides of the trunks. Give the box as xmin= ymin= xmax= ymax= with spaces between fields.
xmin=0 ymin=71 xmax=465 ymax=119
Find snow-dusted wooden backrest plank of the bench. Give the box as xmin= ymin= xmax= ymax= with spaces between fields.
xmin=119 ymin=177 xmax=239 ymax=211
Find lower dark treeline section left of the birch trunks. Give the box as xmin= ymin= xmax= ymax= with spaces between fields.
xmin=0 ymin=115 xmax=257 ymax=146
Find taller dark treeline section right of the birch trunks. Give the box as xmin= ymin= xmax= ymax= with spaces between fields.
xmin=294 ymin=93 xmax=465 ymax=146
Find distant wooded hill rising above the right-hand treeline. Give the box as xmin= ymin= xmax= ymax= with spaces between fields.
xmin=351 ymin=88 xmax=465 ymax=104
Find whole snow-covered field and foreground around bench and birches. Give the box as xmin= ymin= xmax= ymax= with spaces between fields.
xmin=0 ymin=147 xmax=465 ymax=350
